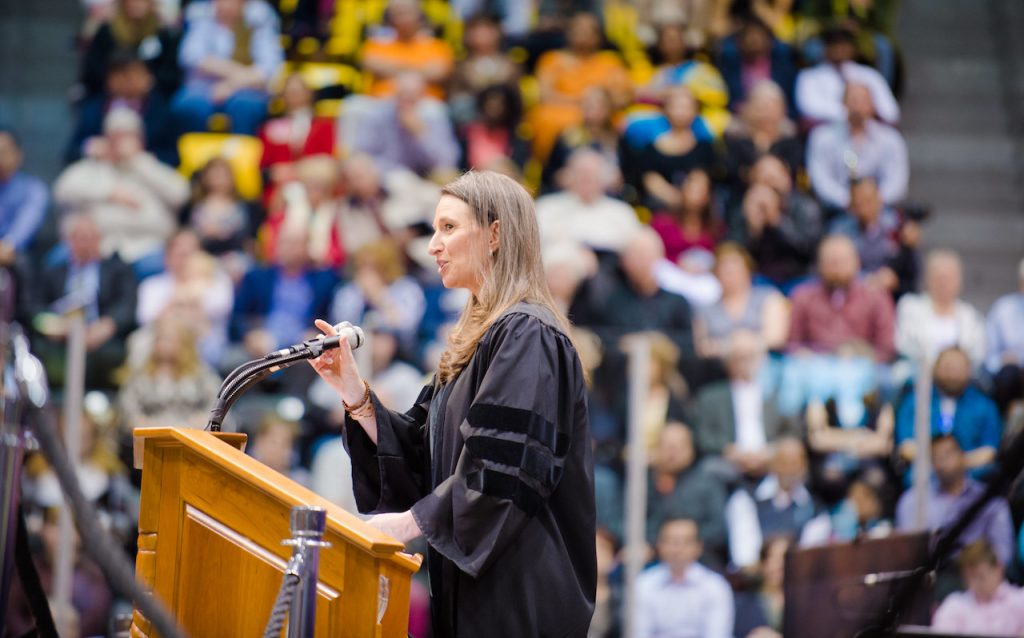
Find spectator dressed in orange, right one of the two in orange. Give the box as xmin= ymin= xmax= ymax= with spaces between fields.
xmin=528 ymin=12 xmax=632 ymax=159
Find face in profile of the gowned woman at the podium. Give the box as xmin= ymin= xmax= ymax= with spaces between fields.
xmin=427 ymin=195 xmax=497 ymax=295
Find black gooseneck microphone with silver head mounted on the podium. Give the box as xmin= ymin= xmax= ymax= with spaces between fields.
xmin=206 ymin=322 xmax=364 ymax=432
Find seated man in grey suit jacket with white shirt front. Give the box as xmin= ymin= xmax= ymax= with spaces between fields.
xmin=694 ymin=331 xmax=801 ymax=480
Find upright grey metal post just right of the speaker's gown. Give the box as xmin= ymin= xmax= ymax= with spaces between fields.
xmin=624 ymin=334 xmax=650 ymax=637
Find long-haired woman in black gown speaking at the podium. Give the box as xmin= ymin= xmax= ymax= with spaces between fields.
xmin=312 ymin=172 xmax=597 ymax=638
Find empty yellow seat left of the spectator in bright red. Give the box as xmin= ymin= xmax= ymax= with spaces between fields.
xmin=178 ymin=133 xmax=263 ymax=200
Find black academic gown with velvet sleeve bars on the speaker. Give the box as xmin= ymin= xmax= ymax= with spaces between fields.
xmin=344 ymin=304 xmax=597 ymax=638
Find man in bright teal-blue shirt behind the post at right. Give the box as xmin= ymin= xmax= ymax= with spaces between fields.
xmin=896 ymin=347 xmax=1002 ymax=477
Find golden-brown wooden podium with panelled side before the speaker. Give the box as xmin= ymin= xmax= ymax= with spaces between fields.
xmin=131 ymin=428 xmax=421 ymax=638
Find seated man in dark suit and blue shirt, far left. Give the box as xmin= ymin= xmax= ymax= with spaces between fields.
xmin=18 ymin=213 xmax=138 ymax=388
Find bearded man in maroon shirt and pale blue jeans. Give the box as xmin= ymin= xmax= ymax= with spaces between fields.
xmin=779 ymin=235 xmax=896 ymax=427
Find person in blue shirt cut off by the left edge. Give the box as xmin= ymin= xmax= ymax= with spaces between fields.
xmin=0 ymin=127 xmax=49 ymax=267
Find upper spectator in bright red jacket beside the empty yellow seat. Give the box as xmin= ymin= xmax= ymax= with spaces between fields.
xmin=259 ymin=73 xmax=335 ymax=205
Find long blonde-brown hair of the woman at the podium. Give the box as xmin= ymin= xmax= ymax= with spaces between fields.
xmin=437 ymin=171 xmax=571 ymax=383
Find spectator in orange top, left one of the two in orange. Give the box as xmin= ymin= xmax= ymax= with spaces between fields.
xmin=361 ymin=0 xmax=455 ymax=99
